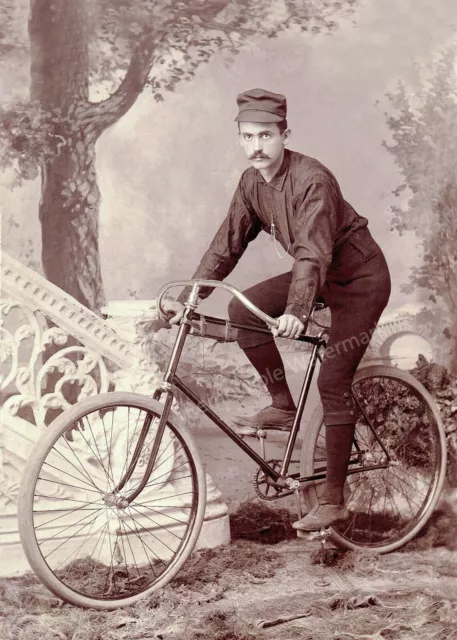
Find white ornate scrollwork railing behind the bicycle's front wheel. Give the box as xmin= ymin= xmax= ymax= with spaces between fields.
xmin=0 ymin=253 xmax=229 ymax=575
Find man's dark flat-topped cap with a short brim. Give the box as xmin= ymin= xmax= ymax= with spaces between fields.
xmin=235 ymin=89 xmax=287 ymax=122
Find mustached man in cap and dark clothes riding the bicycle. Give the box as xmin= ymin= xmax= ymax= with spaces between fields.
xmin=164 ymin=89 xmax=390 ymax=531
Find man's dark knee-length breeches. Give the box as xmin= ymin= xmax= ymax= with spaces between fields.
xmin=229 ymin=228 xmax=390 ymax=425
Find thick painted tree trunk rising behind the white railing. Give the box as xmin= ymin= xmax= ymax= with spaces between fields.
xmin=29 ymin=0 xmax=104 ymax=311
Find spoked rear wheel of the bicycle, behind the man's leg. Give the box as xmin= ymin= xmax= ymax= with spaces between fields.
xmin=301 ymin=365 xmax=446 ymax=553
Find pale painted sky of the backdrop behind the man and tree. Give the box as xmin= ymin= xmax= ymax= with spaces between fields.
xmin=0 ymin=0 xmax=457 ymax=344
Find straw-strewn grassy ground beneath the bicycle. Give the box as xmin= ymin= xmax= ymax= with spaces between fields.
xmin=0 ymin=504 xmax=457 ymax=640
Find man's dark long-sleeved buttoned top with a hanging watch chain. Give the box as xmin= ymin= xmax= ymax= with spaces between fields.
xmin=178 ymin=149 xmax=368 ymax=325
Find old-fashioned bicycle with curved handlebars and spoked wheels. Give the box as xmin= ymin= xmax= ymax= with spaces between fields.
xmin=18 ymin=280 xmax=446 ymax=609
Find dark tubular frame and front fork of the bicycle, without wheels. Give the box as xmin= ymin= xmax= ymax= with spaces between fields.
xmin=114 ymin=283 xmax=387 ymax=503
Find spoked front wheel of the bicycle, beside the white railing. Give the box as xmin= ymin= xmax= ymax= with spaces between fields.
xmin=18 ymin=393 xmax=206 ymax=609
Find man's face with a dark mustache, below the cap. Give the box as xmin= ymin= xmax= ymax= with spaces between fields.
xmin=239 ymin=122 xmax=289 ymax=170
